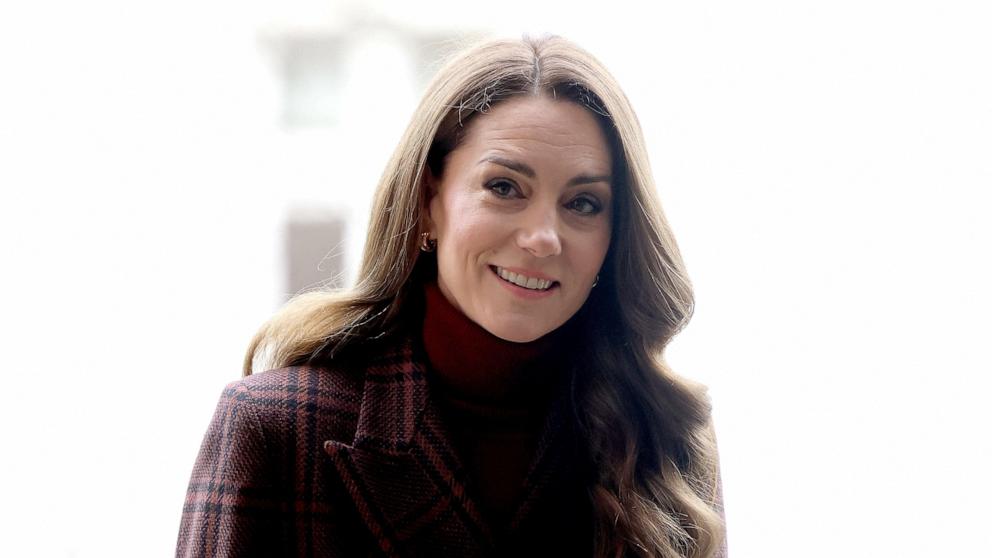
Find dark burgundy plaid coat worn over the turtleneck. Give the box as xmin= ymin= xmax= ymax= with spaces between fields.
xmin=176 ymin=332 xmax=592 ymax=557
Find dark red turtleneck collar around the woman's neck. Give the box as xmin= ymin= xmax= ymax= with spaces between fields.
xmin=423 ymin=282 xmax=568 ymax=407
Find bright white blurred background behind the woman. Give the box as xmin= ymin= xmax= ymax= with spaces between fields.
xmin=0 ymin=0 xmax=992 ymax=558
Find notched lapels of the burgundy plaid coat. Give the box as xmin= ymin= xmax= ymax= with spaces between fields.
xmin=324 ymin=335 xmax=565 ymax=556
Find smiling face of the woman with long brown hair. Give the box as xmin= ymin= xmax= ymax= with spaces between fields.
xmin=428 ymin=96 xmax=612 ymax=342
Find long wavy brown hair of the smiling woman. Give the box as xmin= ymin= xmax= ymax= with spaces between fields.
xmin=244 ymin=37 xmax=723 ymax=558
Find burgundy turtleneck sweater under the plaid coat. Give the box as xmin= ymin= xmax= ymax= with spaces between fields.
xmin=423 ymin=283 xmax=567 ymax=532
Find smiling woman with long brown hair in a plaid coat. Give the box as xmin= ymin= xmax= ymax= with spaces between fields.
xmin=178 ymin=38 xmax=725 ymax=558
